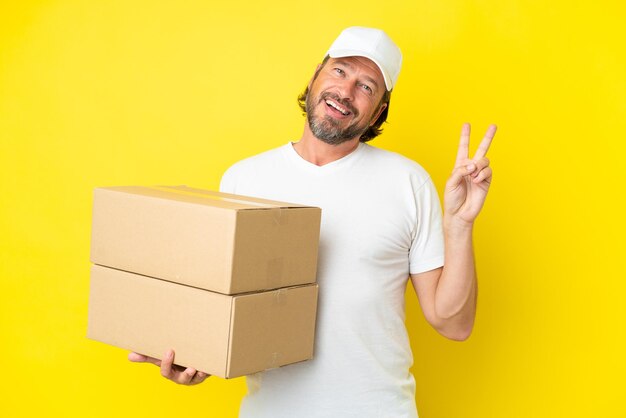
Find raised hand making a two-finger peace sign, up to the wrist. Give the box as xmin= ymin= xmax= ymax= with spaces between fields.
xmin=443 ymin=123 xmax=497 ymax=226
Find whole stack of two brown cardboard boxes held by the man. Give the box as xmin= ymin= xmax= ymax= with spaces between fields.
xmin=87 ymin=186 xmax=321 ymax=378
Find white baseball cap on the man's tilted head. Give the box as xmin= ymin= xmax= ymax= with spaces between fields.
xmin=326 ymin=26 xmax=402 ymax=91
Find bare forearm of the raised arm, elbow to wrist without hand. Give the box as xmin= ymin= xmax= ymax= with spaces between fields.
xmin=435 ymin=219 xmax=477 ymax=335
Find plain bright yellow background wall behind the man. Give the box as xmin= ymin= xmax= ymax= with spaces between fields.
xmin=0 ymin=0 xmax=626 ymax=418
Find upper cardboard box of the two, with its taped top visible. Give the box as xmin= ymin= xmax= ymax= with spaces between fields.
xmin=91 ymin=186 xmax=321 ymax=294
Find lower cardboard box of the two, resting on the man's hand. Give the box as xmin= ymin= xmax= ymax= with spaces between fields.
xmin=87 ymin=265 xmax=318 ymax=378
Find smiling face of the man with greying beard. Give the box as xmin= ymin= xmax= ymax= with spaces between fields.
xmin=306 ymin=57 xmax=387 ymax=145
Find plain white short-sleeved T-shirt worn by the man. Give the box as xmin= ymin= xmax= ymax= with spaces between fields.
xmin=220 ymin=143 xmax=443 ymax=418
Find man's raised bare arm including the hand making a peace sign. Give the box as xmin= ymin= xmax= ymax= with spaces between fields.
xmin=420 ymin=123 xmax=496 ymax=340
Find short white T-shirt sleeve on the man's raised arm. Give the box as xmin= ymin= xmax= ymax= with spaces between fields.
xmin=409 ymin=177 xmax=444 ymax=274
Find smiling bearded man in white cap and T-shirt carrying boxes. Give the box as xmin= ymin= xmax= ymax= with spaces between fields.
xmin=129 ymin=27 xmax=496 ymax=418
